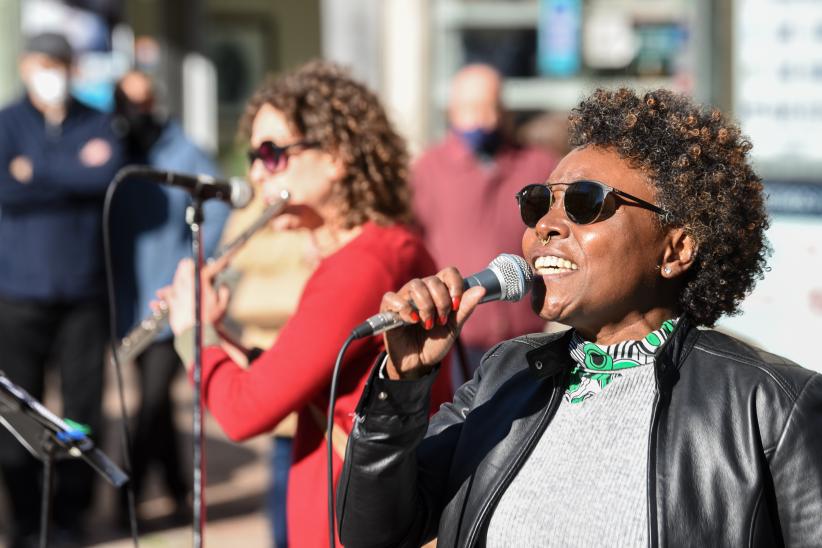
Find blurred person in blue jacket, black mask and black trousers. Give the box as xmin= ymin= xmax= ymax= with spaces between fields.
xmin=111 ymin=71 xmax=229 ymax=519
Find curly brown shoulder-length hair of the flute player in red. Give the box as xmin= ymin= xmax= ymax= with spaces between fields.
xmin=240 ymin=61 xmax=411 ymax=228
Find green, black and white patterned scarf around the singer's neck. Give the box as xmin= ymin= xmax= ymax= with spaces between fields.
xmin=565 ymin=318 xmax=678 ymax=403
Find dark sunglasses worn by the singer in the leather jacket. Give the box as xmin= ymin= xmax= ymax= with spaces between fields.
xmin=516 ymin=181 xmax=668 ymax=228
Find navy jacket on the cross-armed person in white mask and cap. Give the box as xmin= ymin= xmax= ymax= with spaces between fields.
xmin=0 ymin=98 xmax=123 ymax=302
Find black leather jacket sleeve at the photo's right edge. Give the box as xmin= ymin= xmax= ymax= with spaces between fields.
xmin=770 ymin=374 xmax=822 ymax=546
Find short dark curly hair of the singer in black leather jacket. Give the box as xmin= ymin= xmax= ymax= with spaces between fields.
xmin=569 ymin=88 xmax=770 ymax=326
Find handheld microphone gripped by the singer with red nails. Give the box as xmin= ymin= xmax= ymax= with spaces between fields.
xmin=351 ymin=253 xmax=534 ymax=339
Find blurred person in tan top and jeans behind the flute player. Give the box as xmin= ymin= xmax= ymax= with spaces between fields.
xmin=223 ymin=195 xmax=317 ymax=548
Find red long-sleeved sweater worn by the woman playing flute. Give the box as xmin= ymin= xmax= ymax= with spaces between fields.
xmin=202 ymin=223 xmax=451 ymax=548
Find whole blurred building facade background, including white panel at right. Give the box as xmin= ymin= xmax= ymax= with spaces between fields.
xmin=0 ymin=0 xmax=822 ymax=374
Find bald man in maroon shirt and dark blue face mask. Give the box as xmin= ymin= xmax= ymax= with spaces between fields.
xmin=411 ymin=64 xmax=557 ymax=386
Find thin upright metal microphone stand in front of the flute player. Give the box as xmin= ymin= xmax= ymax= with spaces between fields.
xmin=186 ymin=199 xmax=205 ymax=548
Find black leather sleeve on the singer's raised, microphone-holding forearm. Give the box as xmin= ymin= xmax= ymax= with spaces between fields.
xmin=337 ymin=354 xmax=478 ymax=548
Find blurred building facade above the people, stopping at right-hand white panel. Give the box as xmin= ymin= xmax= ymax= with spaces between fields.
xmin=0 ymin=0 xmax=744 ymax=161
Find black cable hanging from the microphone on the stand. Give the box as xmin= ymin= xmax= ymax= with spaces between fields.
xmin=103 ymin=166 xmax=150 ymax=548
